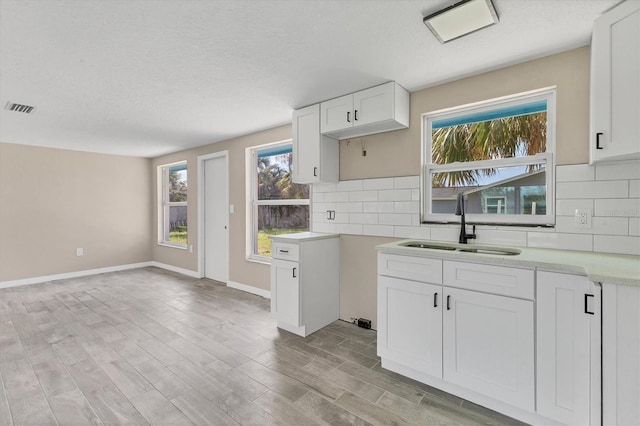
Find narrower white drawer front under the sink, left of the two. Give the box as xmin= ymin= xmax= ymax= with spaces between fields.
xmin=378 ymin=253 xmax=442 ymax=284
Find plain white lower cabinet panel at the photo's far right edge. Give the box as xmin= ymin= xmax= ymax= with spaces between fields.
xmin=602 ymin=283 xmax=640 ymax=425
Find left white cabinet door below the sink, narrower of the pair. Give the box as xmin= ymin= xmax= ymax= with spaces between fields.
xmin=378 ymin=276 xmax=442 ymax=377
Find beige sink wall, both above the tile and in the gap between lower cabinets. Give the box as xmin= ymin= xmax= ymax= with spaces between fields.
xmin=340 ymin=47 xmax=589 ymax=328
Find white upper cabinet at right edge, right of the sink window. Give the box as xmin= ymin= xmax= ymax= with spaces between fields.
xmin=590 ymin=0 xmax=640 ymax=163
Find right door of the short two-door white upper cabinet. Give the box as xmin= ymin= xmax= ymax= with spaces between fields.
xmin=353 ymin=82 xmax=394 ymax=127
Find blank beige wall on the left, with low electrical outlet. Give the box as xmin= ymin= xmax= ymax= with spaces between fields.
xmin=0 ymin=143 xmax=152 ymax=281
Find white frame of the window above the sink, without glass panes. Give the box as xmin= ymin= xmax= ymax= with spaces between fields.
xmin=420 ymin=87 xmax=556 ymax=227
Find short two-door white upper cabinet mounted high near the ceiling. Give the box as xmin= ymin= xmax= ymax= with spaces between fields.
xmin=320 ymin=81 xmax=409 ymax=138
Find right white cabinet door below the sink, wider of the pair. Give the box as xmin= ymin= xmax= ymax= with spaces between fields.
xmin=442 ymin=287 xmax=534 ymax=411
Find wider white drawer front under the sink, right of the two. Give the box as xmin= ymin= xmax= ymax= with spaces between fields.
xmin=443 ymin=261 xmax=534 ymax=300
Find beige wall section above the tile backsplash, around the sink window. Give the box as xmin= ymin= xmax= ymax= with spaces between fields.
xmin=340 ymin=47 xmax=589 ymax=180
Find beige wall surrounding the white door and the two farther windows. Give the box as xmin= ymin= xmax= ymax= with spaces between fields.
xmin=152 ymin=125 xmax=291 ymax=291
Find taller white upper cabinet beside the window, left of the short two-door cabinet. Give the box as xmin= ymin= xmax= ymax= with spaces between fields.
xmin=292 ymin=104 xmax=339 ymax=183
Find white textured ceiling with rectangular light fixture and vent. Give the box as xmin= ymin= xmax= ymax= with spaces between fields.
xmin=0 ymin=0 xmax=619 ymax=157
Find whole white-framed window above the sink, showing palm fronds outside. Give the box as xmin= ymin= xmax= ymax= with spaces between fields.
xmin=422 ymin=89 xmax=555 ymax=226
